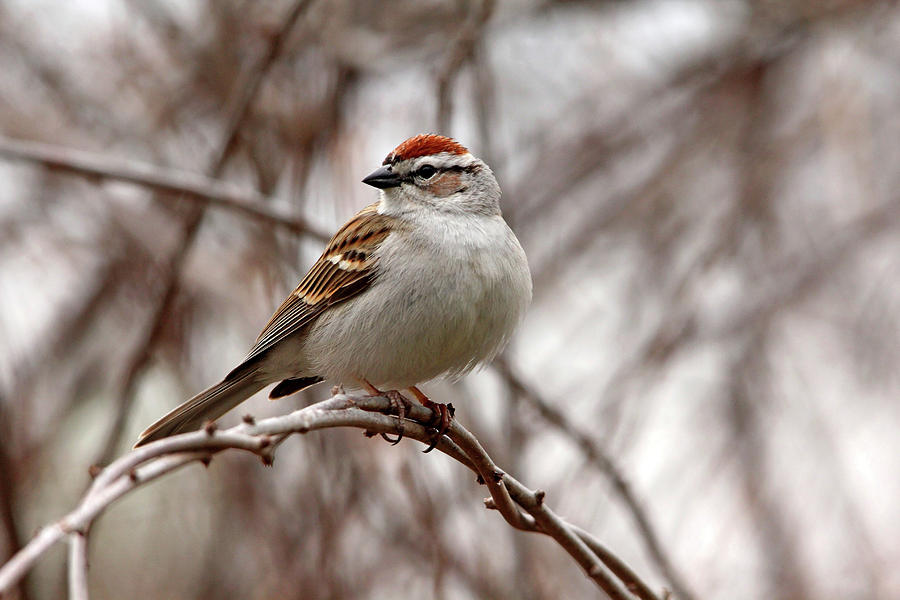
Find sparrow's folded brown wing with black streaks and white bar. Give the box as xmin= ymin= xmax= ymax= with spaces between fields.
xmin=244 ymin=203 xmax=398 ymax=364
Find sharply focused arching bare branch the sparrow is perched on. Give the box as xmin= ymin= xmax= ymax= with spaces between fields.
xmin=0 ymin=393 xmax=659 ymax=600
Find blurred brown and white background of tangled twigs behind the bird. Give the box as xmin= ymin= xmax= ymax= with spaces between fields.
xmin=0 ymin=0 xmax=900 ymax=600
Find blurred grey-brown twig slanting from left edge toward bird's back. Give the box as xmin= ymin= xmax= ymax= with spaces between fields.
xmin=0 ymin=136 xmax=328 ymax=240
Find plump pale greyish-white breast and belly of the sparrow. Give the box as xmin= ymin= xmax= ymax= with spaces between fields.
xmin=303 ymin=215 xmax=531 ymax=389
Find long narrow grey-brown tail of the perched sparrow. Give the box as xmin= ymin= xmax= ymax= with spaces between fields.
xmin=134 ymin=368 xmax=266 ymax=448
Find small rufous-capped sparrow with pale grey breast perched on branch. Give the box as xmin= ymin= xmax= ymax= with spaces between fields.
xmin=135 ymin=134 xmax=532 ymax=449
